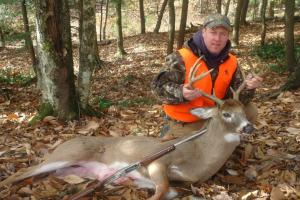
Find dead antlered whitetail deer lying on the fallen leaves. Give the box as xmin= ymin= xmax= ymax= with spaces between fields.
xmin=0 ymin=61 xmax=253 ymax=200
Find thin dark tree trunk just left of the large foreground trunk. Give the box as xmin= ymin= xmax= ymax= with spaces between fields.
xmin=21 ymin=0 xmax=37 ymax=74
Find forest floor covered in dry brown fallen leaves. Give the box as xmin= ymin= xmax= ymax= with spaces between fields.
xmin=0 ymin=20 xmax=300 ymax=200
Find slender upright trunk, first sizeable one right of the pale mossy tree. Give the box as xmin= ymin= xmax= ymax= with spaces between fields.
xmin=115 ymin=0 xmax=126 ymax=57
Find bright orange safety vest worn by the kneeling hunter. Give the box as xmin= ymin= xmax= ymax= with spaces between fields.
xmin=163 ymin=48 xmax=237 ymax=122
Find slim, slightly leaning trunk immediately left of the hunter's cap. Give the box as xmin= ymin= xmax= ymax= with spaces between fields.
xmin=177 ymin=0 xmax=189 ymax=49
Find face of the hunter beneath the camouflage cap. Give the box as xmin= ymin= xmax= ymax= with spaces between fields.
xmin=202 ymin=26 xmax=229 ymax=55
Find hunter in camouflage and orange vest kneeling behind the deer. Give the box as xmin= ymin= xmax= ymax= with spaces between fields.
xmin=152 ymin=14 xmax=262 ymax=136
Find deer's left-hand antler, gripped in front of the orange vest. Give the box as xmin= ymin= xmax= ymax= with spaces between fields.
xmin=188 ymin=55 xmax=224 ymax=105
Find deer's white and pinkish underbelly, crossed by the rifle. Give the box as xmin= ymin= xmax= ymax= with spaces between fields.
xmin=55 ymin=162 xmax=155 ymax=188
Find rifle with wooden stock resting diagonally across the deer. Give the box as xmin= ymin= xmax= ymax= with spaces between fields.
xmin=69 ymin=129 xmax=206 ymax=200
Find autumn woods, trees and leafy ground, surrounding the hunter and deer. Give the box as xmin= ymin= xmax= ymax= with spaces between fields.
xmin=0 ymin=0 xmax=300 ymax=199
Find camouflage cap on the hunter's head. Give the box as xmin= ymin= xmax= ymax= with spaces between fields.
xmin=203 ymin=14 xmax=231 ymax=31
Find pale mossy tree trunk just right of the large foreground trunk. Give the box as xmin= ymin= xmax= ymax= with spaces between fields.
xmin=78 ymin=0 xmax=99 ymax=110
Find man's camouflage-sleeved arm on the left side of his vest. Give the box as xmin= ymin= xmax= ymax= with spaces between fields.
xmin=151 ymin=52 xmax=186 ymax=104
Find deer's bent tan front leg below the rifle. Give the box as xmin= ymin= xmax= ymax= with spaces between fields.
xmin=148 ymin=162 xmax=169 ymax=200
